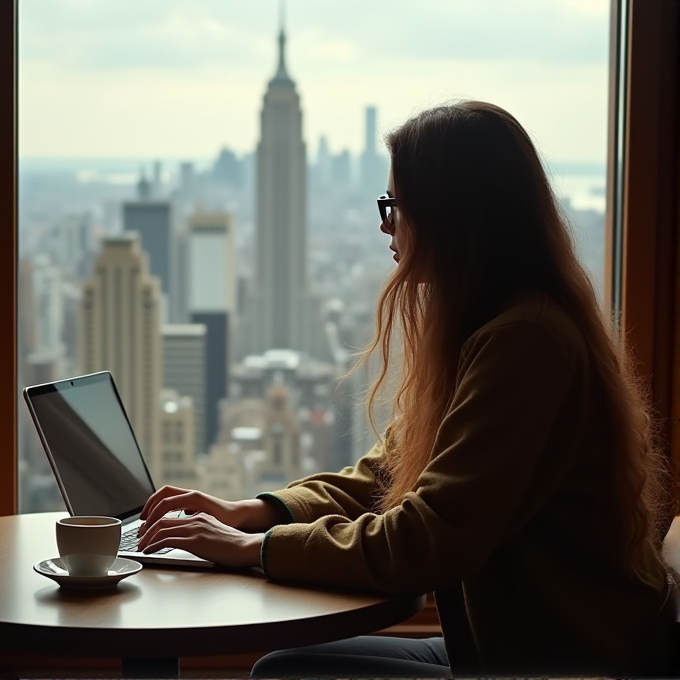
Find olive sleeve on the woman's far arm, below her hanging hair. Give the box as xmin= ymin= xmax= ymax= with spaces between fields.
xmin=257 ymin=442 xmax=384 ymax=523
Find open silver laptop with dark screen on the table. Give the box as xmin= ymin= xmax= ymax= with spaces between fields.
xmin=23 ymin=371 xmax=215 ymax=567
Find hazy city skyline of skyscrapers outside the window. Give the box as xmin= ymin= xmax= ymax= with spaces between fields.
xmin=18 ymin=7 xmax=604 ymax=507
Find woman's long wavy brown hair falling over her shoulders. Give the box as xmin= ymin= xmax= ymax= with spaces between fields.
xmin=363 ymin=101 xmax=669 ymax=576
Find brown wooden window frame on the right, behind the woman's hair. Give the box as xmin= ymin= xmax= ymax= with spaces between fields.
xmin=605 ymin=0 xmax=680 ymax=500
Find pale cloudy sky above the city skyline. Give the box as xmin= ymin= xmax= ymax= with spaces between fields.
xmin=19 ymin=0 xmax=609 ymax=163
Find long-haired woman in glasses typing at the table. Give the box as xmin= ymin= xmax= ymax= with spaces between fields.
xmin=141 ymin=102 xmax=673 ymax=677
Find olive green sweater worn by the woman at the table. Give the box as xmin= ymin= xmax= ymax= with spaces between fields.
xmin=262 ymin=293 xmax=673 ymax=675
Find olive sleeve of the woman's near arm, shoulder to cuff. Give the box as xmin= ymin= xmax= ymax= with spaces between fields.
xmin=262 ymin=321 xmax=572 ymax=593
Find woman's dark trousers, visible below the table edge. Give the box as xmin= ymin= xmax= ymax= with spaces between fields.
xmin=250 ymin=635 xmax=451 ymax=678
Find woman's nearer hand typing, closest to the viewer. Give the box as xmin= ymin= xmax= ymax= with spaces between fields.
xmin=139 ymin=512 xmax=264 ymax=567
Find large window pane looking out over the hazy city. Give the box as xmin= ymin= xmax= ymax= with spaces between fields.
xmin=18 ymin=0 xmax=609 ymax=511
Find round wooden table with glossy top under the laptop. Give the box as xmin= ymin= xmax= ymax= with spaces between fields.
xmin=0 ymin=513 xmax=425 ymax=677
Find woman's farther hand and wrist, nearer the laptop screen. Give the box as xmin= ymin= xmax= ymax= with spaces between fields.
xmin=139 ymin=486 xmax=280 ymax=536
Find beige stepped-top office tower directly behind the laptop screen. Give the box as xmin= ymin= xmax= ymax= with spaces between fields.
xmin=78 ymin=232 xmax=163 ymax=477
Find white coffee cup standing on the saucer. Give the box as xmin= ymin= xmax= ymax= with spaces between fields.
xmin=57 ymin=516 xmax=121 ymax=576
